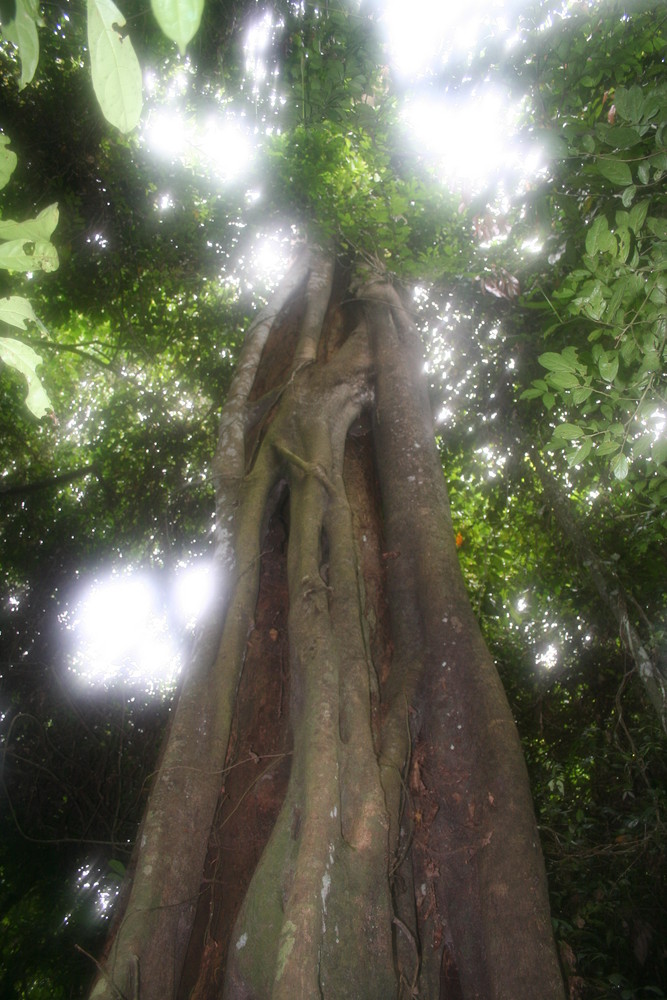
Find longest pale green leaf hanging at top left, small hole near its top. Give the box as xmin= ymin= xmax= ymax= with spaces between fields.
xmin=87 ymin=0 xmax=143 ymax=132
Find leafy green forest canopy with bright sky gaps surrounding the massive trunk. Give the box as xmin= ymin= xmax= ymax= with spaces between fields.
xmin=0 ymin=0 xmax=667 ymax=1000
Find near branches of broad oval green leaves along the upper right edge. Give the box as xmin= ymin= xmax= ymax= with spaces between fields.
xmin=523 ymin=78 xmax=667 ymax=501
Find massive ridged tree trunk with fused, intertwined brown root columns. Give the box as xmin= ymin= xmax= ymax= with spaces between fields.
xmin=87 ymin=253 xmax=564 ymax=1000
